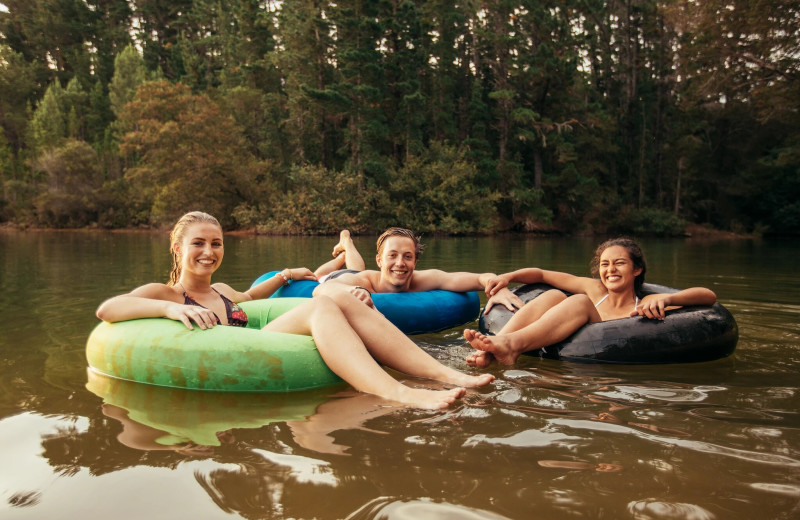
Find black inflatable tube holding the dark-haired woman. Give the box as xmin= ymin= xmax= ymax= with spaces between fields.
xmin=479 ymin=283 xmax=739 ymax=364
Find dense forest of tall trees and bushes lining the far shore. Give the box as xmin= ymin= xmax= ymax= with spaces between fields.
xmin=0 ymin=0 xmax=800 ymax=235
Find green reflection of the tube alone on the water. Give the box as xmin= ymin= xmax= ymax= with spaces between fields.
xmin=86 ymin=370 xmax=338 ymax=446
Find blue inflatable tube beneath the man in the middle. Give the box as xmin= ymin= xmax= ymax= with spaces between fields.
xmin=251 ymin=271 xmax=481 ymax=334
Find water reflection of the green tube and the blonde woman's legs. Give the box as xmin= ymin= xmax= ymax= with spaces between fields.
xmin=86 ymin=370 xmax=412 ymax=456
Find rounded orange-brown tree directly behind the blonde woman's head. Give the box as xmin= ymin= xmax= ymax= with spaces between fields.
xmin=120 ymin=81 xmax=260 ymax=223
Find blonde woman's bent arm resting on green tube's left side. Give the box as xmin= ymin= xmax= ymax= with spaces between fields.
xmin=96 ymin=283 xmax=217 ymax=329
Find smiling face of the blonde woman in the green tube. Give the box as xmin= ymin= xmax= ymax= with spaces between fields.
xmin=173 ymin=222 xmax=225 ymax=277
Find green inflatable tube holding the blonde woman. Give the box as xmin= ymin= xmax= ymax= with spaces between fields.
xmin=86 ymin=298 xmax=341 ymax=392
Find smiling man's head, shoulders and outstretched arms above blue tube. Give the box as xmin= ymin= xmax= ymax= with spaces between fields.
xmin=310 ymin=227 xmax=523 ymax=310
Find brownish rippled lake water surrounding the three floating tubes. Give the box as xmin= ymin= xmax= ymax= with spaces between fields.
xmin=0 ymin=231 xmax=800 ymax=520
